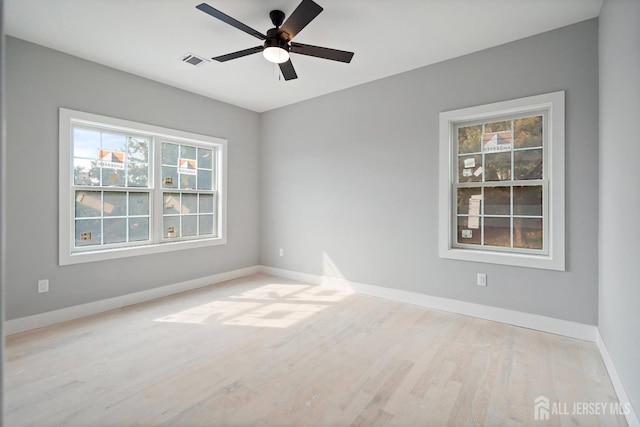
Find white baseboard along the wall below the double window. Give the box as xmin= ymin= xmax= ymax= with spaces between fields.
xmin=4 ymin=266 xmax=259 ymax=335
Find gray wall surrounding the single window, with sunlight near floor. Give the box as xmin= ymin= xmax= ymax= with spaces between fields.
xmin=260 ymin=19 xmax=598 ymax=325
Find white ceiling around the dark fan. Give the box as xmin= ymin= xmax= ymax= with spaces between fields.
xmin=5 ymin=0 xmax=602 ymax=112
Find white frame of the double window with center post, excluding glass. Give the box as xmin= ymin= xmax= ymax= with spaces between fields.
xmin=59 ymin=108 xmax=227 ymax=265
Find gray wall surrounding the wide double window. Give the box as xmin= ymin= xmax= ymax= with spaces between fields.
xmin=6 ymin=37 xmax=260 ymax=319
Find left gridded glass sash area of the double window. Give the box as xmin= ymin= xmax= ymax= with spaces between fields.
xmin=71 ymin=124 xmax=152 ymax=252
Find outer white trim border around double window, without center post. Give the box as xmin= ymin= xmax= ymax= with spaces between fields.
xmin=58 ymin=108 xmax=228 ymax=266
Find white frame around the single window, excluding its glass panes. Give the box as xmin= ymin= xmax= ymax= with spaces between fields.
xmin=438 ymin=91 xmax=565 ymax=271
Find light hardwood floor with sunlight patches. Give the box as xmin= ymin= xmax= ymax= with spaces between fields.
xmin=5 ymin=275 xmax=626 ymax=427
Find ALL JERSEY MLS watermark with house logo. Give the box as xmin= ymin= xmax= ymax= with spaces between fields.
xmin=533 ymin=396 xmax=631 ymax=421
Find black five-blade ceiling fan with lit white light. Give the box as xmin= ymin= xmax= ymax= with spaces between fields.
xmin=196 ymin=0 xmax=353 ymax=80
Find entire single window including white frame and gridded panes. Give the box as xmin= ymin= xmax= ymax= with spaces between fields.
xmin=438 ymin=92 xmax=565 ymax=270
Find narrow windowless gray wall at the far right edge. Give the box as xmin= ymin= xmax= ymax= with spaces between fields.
xmin=599 ymin=0 xmax=640 ymax=415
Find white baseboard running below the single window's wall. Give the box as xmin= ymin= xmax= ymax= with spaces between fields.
xmin=260 ymin=265 xmax=597 ymax=342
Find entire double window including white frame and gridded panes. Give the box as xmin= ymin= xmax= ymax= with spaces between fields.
xmin=60 ymin=109 xmax=226 ymax=265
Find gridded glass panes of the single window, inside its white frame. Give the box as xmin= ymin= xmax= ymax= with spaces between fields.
xmin=453 ymin=111 xmax=548 ymax=253
